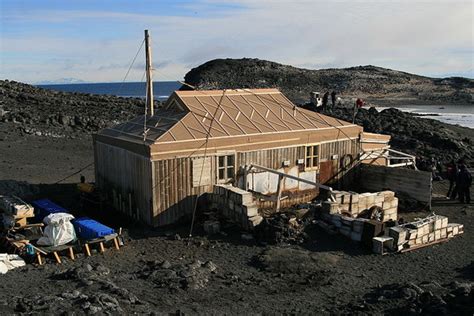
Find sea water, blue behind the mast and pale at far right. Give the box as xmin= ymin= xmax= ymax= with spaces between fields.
xmin=38 ymin=81 xmax=474 ymax=128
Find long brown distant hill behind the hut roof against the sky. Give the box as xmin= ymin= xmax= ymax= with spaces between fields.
xmin=185 ymin=58 xmax=474 ymax=104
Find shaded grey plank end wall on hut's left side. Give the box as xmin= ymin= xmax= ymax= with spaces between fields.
xmin=94 ymin=141 xmax=152 ymax=224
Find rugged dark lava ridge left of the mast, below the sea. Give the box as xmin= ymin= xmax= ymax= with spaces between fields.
xmin=0 ymin=80 xmax=144 ymax=137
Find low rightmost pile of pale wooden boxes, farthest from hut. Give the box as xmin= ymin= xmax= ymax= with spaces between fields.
xmin=389 ymin=215 xmax=464 ymax=251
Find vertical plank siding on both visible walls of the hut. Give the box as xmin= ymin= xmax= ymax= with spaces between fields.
xmin=95 ymin=135 xmax=360 ymax=226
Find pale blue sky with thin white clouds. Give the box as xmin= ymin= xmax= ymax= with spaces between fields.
xmin=0 ymin=0 xmax=474 ymax=83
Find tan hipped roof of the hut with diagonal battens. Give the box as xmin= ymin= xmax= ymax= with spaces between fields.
xmin=100 ymin=89 xmax=353 ymax=144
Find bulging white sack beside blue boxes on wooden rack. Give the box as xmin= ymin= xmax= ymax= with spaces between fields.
xmin=38 ymin=213 xmax=76 ymax=246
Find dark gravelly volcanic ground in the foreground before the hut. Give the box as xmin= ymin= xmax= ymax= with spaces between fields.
xmin=0 ymin=182 xmax=474 ymax=315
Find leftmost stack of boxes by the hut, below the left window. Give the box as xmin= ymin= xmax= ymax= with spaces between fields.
xmin=209 ymin=185 xmax=263 ymax=230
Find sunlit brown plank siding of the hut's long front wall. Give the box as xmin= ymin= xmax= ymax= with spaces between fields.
xmin=151 ymin=139 xmax=359 ymax=226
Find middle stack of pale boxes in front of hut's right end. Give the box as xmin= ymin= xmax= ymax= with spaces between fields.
xmin=323 ymin=191 xmax=398 ymax=222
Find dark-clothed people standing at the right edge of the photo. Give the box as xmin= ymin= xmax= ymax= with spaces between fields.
xmin=446 ymin=160 xmax=472 ymax=204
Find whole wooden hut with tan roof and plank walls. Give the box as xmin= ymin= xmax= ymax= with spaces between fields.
xmin=94 ymin=89 xmax=388 ymax=226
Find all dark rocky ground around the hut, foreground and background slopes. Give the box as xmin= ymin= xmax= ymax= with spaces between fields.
xmin=0 ymin=78 xmax=474 ymax=315
